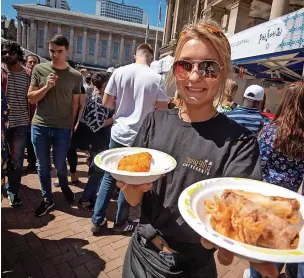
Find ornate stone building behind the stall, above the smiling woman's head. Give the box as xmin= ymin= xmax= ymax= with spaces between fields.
xmin=160 ymin=0 xmax=304 ymax=58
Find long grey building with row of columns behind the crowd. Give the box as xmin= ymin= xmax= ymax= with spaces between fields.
xmin=13 ymin=4 xmax=163 ymax=68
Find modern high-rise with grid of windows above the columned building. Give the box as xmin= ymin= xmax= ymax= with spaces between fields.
xmin=95 ymin=0 xmax=146 ymax=24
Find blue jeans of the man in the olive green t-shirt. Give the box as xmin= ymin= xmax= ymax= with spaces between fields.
xmin=32 ymin=125 xmax=71 ymax=201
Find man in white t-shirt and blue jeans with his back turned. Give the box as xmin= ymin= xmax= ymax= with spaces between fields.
xmin=92 ymin=43 xmax=168 ymax=234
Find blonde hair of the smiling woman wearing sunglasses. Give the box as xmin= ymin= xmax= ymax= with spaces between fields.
xmin=166 ymin=20 xmax=232 ymax=104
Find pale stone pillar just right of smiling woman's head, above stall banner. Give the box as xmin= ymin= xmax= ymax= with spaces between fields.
xmin=228 ymin=0 xmax=252 ymax=36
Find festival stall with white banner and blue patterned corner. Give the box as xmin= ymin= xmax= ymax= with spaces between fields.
xmin=229 ymin=9 xmax=304 ymax=112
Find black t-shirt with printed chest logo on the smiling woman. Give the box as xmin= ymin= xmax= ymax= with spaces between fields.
xmin=133 ymin=110 xmax=261 ymax=249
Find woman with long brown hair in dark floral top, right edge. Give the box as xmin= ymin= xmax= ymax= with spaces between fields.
xmin=246 ymin=81 xmax=304 ymax=278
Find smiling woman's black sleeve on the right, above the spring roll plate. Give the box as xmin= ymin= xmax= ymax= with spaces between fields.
xmin=224 ymin=135 xmax=262 ymax=180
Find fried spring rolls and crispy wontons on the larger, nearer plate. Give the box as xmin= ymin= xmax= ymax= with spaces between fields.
xmin=204 ymin=190 xmax=303 ymax=249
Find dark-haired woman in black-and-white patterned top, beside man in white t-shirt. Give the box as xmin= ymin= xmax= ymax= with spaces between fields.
xmin=73 ymin=72 xmax=114 ymax=210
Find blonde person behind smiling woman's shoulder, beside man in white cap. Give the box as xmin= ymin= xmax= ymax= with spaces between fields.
xmin=216 ymin=78 xmax=239 ymax=113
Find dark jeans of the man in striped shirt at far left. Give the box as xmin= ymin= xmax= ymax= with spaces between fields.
xmin=6 ymin=125 xmax=28 ymax=196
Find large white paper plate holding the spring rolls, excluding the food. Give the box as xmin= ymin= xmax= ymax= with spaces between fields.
xmin=178 ymin=178 xmax=304 ymax=263
